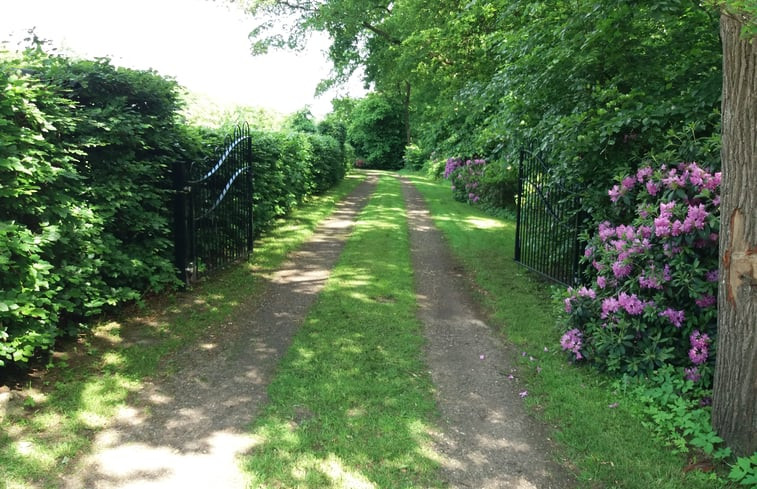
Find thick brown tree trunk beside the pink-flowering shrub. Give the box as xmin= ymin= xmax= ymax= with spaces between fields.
xmin=712 ymin=12 xmax=757 ymax=456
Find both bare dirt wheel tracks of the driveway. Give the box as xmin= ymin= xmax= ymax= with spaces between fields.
xmin=61 ymin=174 xmax=574 ymax=489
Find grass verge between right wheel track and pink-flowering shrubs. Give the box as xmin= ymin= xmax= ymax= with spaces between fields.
xmin=408 ymin=175 xmax=725 ymax=489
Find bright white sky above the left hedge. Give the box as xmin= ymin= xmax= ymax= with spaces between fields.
xmin=0 ymin=0 xmax=363 ymax=117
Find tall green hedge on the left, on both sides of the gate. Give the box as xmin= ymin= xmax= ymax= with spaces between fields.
xmin=0 ymin=51 xmax=345 ymax=367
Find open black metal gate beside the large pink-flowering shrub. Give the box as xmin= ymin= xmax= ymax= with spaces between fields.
xmin=515 ymin=148 xmax=580 ymax=285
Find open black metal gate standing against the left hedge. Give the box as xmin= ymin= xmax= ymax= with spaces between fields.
xmin=174 ymin=123 xmax=254 ymax=282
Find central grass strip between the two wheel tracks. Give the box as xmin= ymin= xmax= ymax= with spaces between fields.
xmin=243 ymin=176 xmax=442 ymax=488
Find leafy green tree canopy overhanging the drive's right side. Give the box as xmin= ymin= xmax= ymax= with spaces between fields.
xmin=249 ymin=0 xmax=722 ymax=208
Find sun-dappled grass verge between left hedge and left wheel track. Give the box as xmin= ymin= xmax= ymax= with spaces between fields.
xmin=0 ymin=174 xmax=363 ymax=489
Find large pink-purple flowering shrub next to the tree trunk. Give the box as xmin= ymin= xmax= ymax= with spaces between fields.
xmin=561 ymin=163 xmax=720 ymax=385
